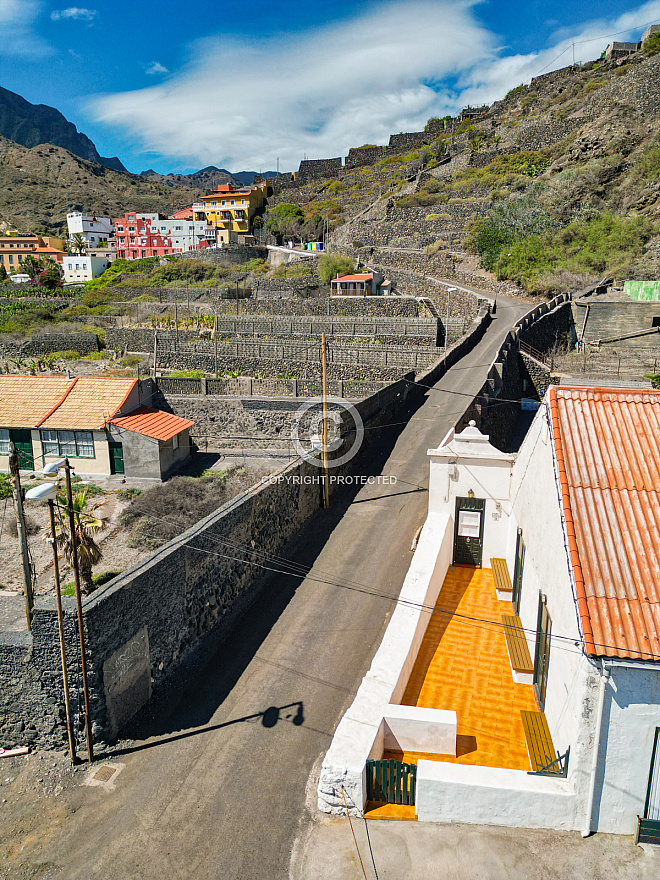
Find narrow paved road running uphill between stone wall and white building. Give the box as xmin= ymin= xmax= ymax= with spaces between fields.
xmin=30 ymin=299 xmax=528 ymax=880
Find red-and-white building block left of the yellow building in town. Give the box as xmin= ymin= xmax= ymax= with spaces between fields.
xmin=114 ymin=212 xmax=215 ymax=260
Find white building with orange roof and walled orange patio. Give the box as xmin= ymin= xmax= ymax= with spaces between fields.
xmin=319 ymin=386 xmax=660 ymax=842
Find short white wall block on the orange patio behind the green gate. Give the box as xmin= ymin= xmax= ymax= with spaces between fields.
xmin=383 ymin=705 xmax=457 ymax=755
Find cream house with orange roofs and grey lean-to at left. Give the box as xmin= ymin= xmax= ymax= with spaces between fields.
xmin=0 ymin=375 xmax=194 ymax=480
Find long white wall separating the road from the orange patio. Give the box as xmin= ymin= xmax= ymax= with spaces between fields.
xmin=318 ymin=514 xmax=454 ymax=815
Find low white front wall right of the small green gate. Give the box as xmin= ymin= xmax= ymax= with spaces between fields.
xmin=415 ymin=761 xmax=579 ymax=831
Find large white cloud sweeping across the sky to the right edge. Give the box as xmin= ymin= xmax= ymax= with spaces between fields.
xmin=92 ymin=0 xmax=660 ymax=169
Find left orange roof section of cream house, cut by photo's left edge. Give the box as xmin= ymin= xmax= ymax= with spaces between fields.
xmin=0 ymin=375 xmax=72 ymax=428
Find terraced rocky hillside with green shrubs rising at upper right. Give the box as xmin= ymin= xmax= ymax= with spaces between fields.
xmin=266 ymin=45 xmax=660 ymax=293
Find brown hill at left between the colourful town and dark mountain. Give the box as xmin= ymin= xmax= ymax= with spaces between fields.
xmin=0 ymin=137 xmax=206 ymax=234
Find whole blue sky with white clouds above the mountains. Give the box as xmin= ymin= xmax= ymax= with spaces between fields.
xmin=0 ymin=0 xmax=660 ymax=173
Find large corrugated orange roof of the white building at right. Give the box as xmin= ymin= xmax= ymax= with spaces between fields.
xmin=549 ymin=387 xmax=660 ymax=661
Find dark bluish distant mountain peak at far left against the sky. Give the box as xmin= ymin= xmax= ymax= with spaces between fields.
xmin=0 ymin=88 xmax=126 ymax=171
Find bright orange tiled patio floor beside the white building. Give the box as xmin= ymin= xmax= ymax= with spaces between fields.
xmin=383 ymin=568 xmax=538 ymax=770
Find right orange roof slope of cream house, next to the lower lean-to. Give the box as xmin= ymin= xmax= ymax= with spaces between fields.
xmin=39 ymin=376 xmax=137 ymax=431
